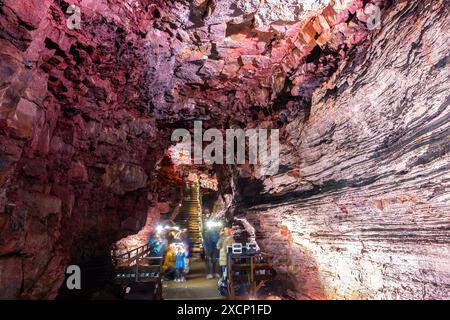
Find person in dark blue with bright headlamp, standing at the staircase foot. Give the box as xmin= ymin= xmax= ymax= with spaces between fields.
xmin=203 ymin=216 xmax=221 ymax=279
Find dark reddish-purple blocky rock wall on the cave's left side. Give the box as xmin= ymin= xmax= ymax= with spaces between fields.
xmin=0 ymin=0 xmax=175 ymax=299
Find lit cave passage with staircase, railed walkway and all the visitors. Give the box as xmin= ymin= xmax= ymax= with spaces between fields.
xmin=110 ymin=170 xmax=264 ymax=300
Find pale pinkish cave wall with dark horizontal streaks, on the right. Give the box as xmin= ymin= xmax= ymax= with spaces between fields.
xmin=234 ymin=1 xmax=450 ymax=299
